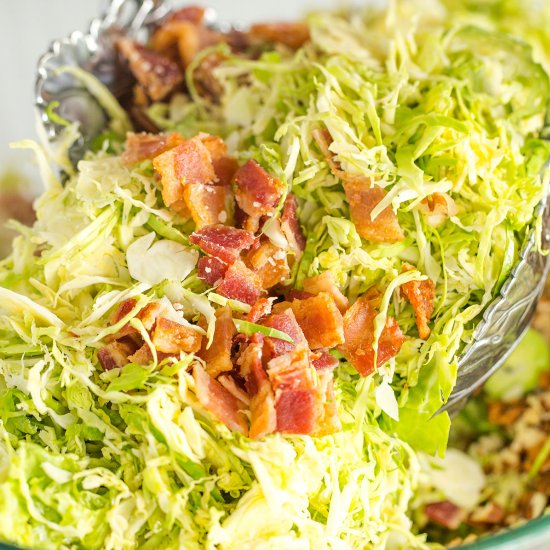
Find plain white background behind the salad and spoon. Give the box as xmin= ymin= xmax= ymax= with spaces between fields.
xmin=0 ymin=0 xmax=340 ymax=188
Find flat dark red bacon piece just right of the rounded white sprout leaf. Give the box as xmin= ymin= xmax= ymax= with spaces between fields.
xmin=189 ymin=224 xmax=254 ymax=264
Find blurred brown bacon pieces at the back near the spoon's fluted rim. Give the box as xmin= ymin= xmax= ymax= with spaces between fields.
xmin=117 ymin=6 xmax=309 ymax=116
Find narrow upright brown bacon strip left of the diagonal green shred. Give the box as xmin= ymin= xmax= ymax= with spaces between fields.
xmin=198 ymin=306 xmax=237 ymax=378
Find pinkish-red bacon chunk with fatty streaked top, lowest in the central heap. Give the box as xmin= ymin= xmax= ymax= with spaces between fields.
xmin=267 ymin=345 xmax=319 ymax=434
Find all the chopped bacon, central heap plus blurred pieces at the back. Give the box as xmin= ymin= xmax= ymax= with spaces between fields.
xmin=98 ymin=7 xmax=446 ymax=438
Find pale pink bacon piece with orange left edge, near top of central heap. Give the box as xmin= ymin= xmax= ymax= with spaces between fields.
xmin=153 ymin=136 xmax=216 ymax=206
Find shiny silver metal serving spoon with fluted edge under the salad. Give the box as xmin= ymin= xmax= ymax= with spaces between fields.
xmin=36 ymin=0 xmax=550 ymax=414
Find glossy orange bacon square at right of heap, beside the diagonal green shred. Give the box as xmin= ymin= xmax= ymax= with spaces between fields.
xmin=290 ymin=292 xmax=344 ymax=349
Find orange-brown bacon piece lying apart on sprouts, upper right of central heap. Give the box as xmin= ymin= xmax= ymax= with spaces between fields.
xmin=344 ymin=178 xmax=405 ymax=243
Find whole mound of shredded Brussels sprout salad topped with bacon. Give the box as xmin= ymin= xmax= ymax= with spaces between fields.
xmin=0 ymin=1 xmax=550 ymax=549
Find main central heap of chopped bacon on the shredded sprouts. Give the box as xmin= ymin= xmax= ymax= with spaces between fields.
xmin=98 ymin=127 xmax=434 ymax=438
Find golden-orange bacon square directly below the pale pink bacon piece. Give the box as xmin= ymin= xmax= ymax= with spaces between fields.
xmin=183 ymin=183 xmax=233 ymax=229
